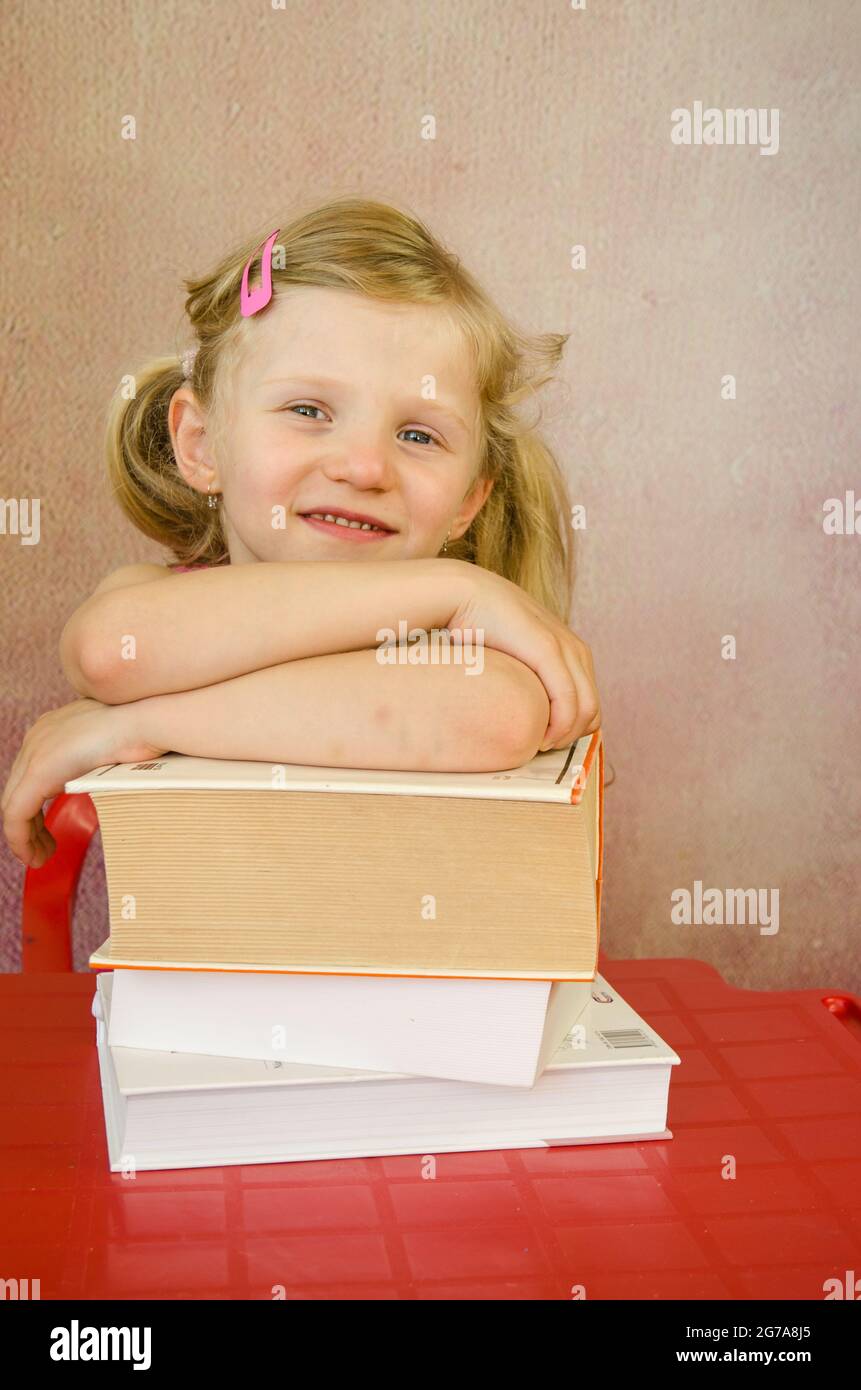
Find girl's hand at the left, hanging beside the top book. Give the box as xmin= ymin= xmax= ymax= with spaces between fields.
xmin=0 ymin=699 xmax=167 ymax=869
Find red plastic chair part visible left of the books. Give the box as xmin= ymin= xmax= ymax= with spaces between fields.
xmin=21 ymin=792 xmax=99 ymax=974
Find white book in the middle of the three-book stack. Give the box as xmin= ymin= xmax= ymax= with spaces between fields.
xmin=99 ymin=969 xmax=591 ymax=1086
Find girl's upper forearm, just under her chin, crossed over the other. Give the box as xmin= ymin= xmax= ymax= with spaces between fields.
xmin=81 ymin=559 xmax=470 ymax=705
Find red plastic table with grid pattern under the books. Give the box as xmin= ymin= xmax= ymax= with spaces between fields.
xmin=0 ymin=959 xmax=861 ymax=1301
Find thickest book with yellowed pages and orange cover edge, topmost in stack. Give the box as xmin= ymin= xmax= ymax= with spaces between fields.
xmin=65 ymin=731 xmax=604 ymax=980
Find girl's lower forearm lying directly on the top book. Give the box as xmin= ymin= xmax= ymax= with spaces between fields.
xmin=125 ymin=651 xmax=548 ymax=771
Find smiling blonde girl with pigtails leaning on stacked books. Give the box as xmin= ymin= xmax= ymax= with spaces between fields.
xmin=1 ymin=199 xmax=601 ymax=867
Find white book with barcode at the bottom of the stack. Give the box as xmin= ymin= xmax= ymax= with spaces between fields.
xmin=93 ymin=973 xmax=680 ymax=1172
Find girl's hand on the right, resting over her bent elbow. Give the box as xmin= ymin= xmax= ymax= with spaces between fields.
xmin=446 ymin=562 xmax=601 ymax=752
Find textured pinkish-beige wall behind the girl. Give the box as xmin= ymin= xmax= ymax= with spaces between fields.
xmin=0 ymin=8 xmax=861 ymax=988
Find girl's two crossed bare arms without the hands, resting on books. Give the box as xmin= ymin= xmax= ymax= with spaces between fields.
xmin=61 ymin=560 xmax=549 ymax=771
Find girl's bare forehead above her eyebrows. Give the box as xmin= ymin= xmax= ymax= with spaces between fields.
xmin=243 ymin=285 xmax=474 ymax=398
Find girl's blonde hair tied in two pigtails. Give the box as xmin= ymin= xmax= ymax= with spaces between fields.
xmin=106 ymin=197 xmax=574 ymax=623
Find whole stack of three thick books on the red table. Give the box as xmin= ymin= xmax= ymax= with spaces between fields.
xmin=65 ymin=733 xmax=679 ymax=1170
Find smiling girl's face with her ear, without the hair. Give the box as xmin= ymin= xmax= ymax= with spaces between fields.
xmin=170 ymin=285 xmax=491 ymax=564
